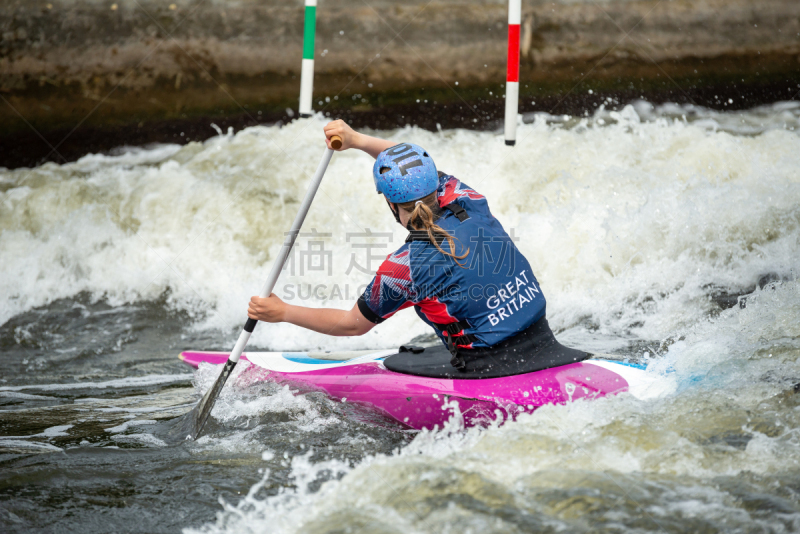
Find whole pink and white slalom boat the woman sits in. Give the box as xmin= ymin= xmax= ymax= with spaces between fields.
xmin=180 ymin=349 xmax=652 ymax=430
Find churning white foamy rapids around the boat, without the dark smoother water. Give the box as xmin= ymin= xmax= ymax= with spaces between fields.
xmin=0 ymin=102 xmax=800 ymax=532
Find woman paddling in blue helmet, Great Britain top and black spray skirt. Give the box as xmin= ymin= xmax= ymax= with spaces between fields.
xmin=248 ymin=120 xmax=589 ymax=378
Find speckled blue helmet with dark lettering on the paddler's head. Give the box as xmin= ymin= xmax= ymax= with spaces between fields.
xmin=372 ymin=143 xmax=439 ymax=203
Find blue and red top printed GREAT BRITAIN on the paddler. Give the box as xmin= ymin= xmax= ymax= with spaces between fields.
xmin=358 ymin=173 xmax=546 ymax=365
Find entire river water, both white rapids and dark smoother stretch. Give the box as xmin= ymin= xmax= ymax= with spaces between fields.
xmin=0 ymin=102 xmax=800 ymax=533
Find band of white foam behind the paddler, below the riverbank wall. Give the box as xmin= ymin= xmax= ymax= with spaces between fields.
xmin=0 ymin=108 xmax=800 ymax=350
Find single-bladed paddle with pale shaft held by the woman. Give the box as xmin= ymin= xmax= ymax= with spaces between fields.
xmin=181 ymin=135 xmax=342 ymax=439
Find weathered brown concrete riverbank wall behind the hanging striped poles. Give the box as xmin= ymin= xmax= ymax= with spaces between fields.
xmin=0 ymin=0 xmax=800 ymax=164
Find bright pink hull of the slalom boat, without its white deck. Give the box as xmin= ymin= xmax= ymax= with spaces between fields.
xmin=181 ymin=352 xmax=629 ymax=430
